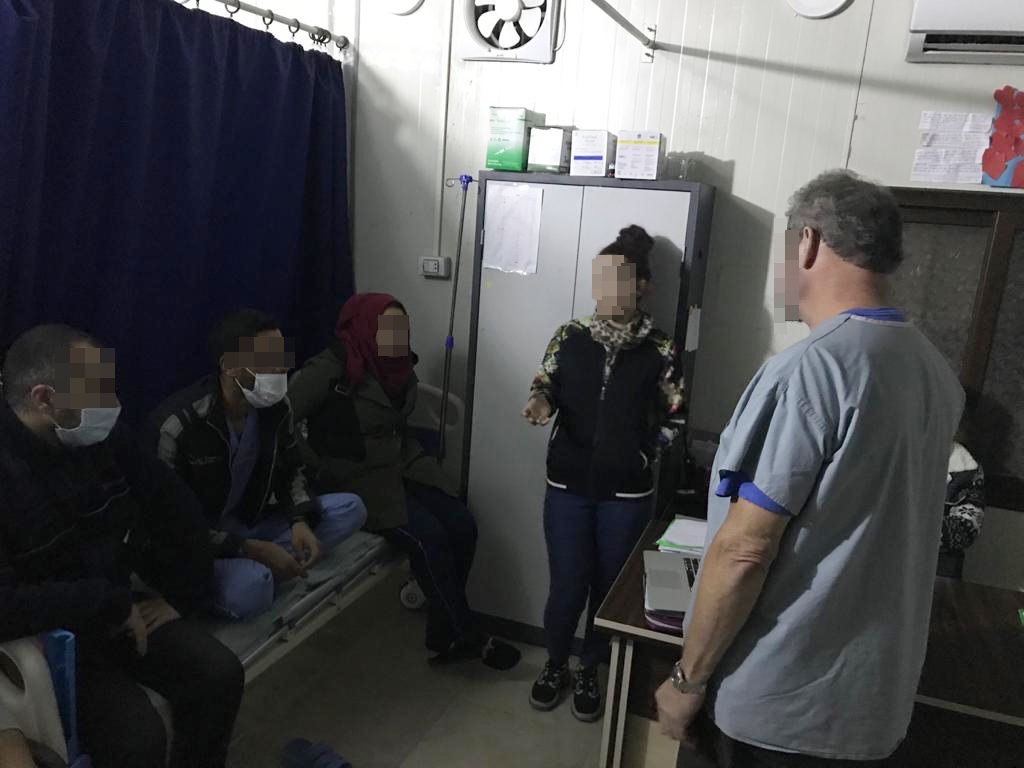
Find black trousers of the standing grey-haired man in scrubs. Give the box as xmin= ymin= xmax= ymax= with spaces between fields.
xmin=676 ymin=713 xmax=894 ymax=768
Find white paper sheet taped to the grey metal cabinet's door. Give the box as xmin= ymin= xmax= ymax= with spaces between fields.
xmin=483 ymin=183 xmax=544 ymax=274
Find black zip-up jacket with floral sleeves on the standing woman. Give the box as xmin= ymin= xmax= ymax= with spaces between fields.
xmin=532 ymin=317 xmax=684 ymax=501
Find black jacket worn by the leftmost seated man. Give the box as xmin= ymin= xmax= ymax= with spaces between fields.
xmin=0 ymin=402 xmax=213 ymax=641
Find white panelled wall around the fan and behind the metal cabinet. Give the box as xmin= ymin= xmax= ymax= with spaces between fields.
xmin=247 ymin=0 xmax=1024 ymax=589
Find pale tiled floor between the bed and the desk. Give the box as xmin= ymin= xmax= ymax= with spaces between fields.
xmin=231 ymin=577 xmax=601 ymax=768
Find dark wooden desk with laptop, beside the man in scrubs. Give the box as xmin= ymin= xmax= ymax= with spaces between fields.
xmin=594 ymin=520 xmax=1024 ymax=768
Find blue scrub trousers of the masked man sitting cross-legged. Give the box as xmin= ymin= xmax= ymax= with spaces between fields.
xmin=213 ymin=494 xmax=367 ymax=618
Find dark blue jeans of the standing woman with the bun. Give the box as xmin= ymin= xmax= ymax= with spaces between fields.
xmin=544 ymin=487 xmax=651 ymax=669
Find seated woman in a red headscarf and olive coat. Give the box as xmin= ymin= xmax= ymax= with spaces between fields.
xmin=288 ymin=293 xmax=519 ymax=669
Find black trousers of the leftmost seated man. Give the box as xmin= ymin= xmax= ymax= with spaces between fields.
xmin=77 ymin=620 xmax=245 ymax=768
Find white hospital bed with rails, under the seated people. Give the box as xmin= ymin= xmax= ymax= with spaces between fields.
xmin=0 ymin=383 xmax=465 ymax=768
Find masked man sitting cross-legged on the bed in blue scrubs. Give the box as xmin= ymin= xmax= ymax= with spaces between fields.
xmin=153 ymin=309 xmax=367 ymax=618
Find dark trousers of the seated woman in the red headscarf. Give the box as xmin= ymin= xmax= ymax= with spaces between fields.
xmin=383 ymin=480 xmax=476 ymax=653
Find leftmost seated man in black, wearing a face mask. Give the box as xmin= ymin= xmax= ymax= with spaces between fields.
xmin=0 ymin=326 xmax=245 ymax=768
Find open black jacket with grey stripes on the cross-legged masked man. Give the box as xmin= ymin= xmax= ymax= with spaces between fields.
xmin=150 ymin=375 xmax=321 ymax=558
